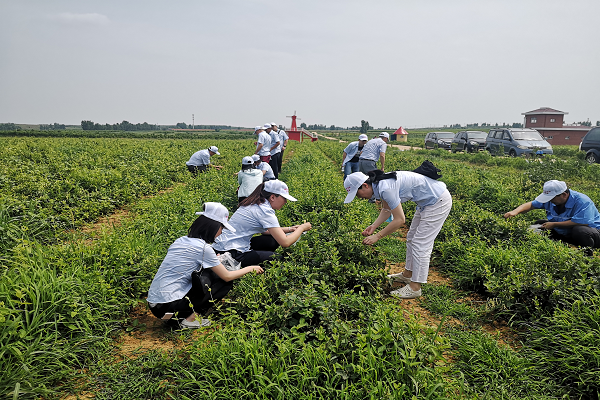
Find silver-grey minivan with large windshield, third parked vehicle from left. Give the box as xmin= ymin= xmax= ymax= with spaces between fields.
xmin=485 ymin=128 xmax=553 ymax=157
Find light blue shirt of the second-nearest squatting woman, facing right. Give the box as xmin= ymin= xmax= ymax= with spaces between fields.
xmin=213 ymin=201 xmax=279 ymax=253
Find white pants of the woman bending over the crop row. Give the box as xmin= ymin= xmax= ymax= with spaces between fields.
xmin=405 ymin=190 xmax=452 ymax=283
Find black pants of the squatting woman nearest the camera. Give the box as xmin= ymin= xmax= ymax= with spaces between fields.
xmin=150 ymin=268 xmax=233 ymax=328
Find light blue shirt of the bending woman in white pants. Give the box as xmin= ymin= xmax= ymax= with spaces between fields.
xmin=373 ymin=171 xmax=447 ymax=210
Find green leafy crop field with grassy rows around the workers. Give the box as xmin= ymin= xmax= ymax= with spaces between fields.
xmin=0 ymin=137 xmax=600 ymax=399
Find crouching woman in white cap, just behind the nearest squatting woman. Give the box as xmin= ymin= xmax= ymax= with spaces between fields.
xmin=214 ymin=179 xmax=312 ymax=267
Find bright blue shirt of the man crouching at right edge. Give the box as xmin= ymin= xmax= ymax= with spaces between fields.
xmin=531 ymin=190 xmax=600 ymax=235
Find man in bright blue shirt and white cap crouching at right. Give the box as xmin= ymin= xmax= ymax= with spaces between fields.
xmin=504 ymin=180 xmax=600 ymax=255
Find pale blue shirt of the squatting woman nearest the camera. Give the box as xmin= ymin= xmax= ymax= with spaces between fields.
xmin=148 ymin=236 xmax=221 ymax=303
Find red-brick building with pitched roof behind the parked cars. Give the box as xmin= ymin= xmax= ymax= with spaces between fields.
xmin=521 ymin=107 xmax=590 ymax=145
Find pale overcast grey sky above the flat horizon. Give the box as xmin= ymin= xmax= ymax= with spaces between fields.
xmin=0 ymin=0 xmax=600 ymax=128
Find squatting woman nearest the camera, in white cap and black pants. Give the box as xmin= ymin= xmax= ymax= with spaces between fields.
xmin=147 ymin=202 xmax=263 ymax=328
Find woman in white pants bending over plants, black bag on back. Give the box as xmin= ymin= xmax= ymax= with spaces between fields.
xmin=344 ymin=170 xmax=452 ymax=299
